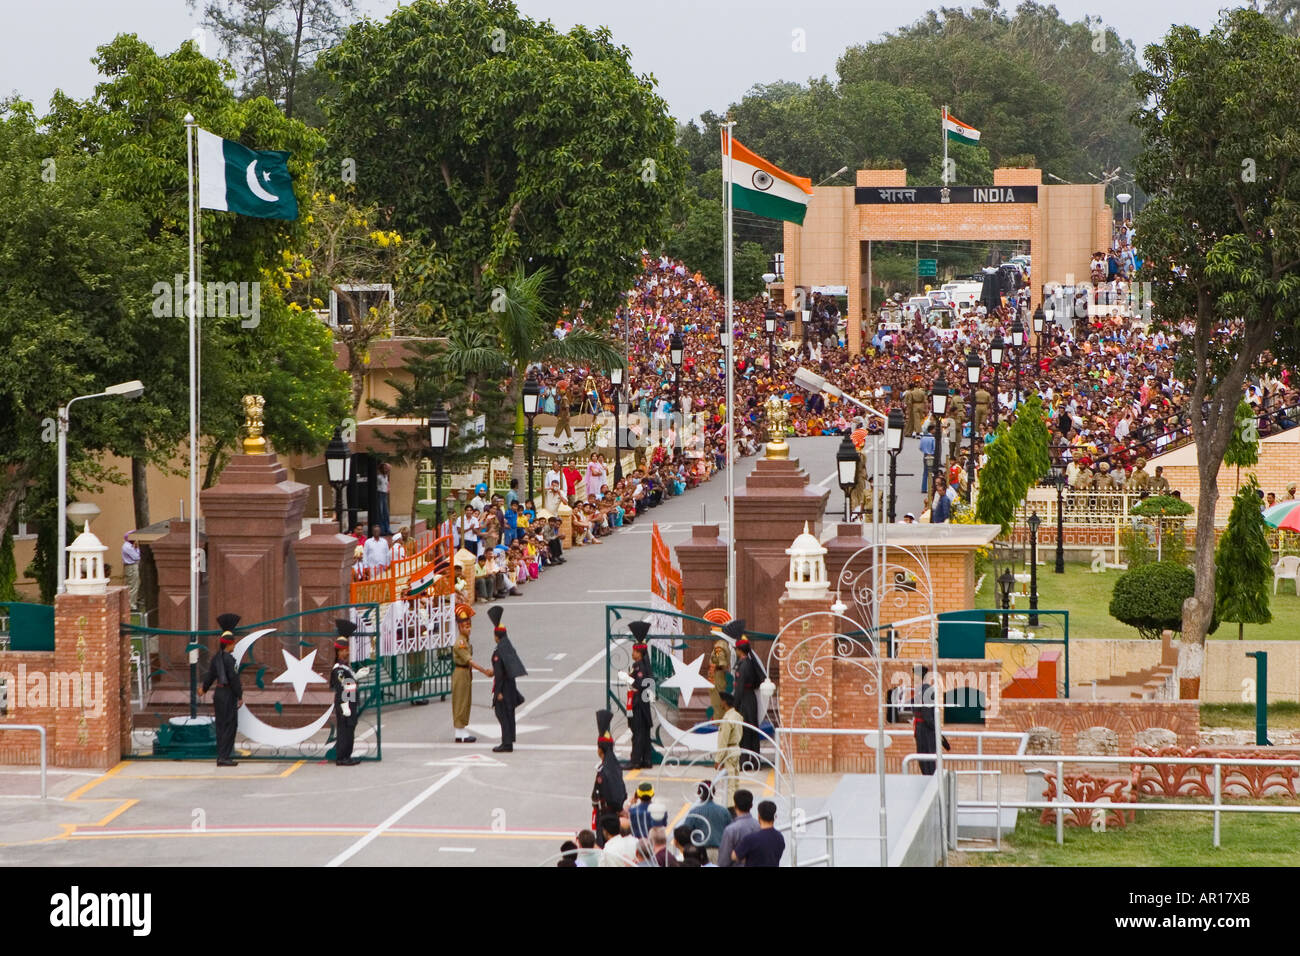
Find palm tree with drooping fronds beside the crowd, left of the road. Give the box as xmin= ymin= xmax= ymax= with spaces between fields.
xmin=447 ymin=265 xmax=623 ymax=479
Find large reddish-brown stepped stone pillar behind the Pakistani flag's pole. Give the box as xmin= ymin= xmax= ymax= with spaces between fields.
xmin=200 ymin=454 xmax=308 ymax=627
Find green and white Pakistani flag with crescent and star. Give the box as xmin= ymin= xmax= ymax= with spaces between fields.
xmin=198 ymin=129 xmax=298 ymax=219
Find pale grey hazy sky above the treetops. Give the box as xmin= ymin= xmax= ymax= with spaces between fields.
xmin=0 ymin=0 xmax=1229 ymax=118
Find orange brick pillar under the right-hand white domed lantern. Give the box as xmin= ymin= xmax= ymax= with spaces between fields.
xmin=768 ymin=593 xmax=852 ymax=774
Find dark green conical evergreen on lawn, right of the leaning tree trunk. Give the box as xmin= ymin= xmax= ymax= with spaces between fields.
xmin=1214 ymin=475 xmax=1273 ymax=640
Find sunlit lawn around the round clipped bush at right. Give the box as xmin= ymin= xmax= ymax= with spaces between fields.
xmin=975 ymin=567 xmax=1300 ymax=642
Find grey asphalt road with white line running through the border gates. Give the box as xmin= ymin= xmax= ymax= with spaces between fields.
xmin=0 ymin=438 xmax=920 ymax=866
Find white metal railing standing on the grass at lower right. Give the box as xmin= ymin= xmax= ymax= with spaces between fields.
xmin=902 ymin=753 xmax=1300 ymax=847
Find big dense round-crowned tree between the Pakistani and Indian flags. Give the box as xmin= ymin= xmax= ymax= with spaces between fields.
xmin=317 ymin=0 xmax=685 ymax=323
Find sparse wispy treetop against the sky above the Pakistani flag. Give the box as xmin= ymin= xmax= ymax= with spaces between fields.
xmin=189 ymin=0 xmax=356 ymax=126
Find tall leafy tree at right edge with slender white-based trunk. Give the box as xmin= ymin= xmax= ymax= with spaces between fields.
xmin=1134 ymin=9 xmax=1300 ymax=698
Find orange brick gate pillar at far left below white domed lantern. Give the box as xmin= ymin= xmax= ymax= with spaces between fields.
xmin=47 ymin=588 xmax=131 ymax=769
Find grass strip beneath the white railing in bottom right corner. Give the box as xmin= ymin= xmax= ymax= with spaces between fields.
xmin=957 ymin=800 xmax=1300 ymax=866
